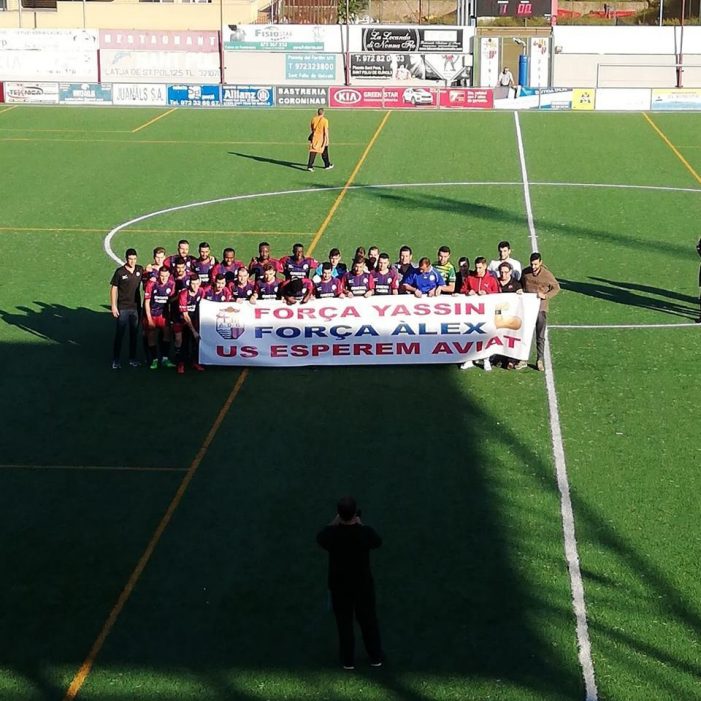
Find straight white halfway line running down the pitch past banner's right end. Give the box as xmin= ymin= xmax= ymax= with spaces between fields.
xmin=514 ymin=112 xmax=598 ymax=701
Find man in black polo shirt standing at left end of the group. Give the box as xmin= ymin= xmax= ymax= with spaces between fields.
xmin=110 ymin=248 xmax=144 ymax=370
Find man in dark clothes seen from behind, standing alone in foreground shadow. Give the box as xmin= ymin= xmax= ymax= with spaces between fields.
xmin=316 ymin=497 xmax=384 ymax=669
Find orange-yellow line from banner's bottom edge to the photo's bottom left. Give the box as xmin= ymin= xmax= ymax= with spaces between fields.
xmin=63 ymin=368 xmax=248 ymax=701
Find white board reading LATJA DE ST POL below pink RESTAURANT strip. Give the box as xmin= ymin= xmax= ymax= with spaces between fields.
xmin=100 ymin=49 xmax=221 ymax=83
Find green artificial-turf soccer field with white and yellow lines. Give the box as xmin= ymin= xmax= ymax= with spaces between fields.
xmin=0 ymin=106 xmax=701 ymax=701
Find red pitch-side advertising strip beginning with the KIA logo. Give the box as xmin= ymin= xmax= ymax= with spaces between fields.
xmin=329 ymin=85 xmax=494 ymax=109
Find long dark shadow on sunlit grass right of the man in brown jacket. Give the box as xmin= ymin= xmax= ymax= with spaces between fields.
xmin=558 ymin=277 xmax=696 ymax=318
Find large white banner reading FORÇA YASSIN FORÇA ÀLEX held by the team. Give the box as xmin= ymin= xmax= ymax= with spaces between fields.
xmin=200 ymin=294 xmax=540 ymax=367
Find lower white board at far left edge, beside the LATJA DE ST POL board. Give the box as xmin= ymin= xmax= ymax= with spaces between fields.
xmin=0 ymin=49 xmax=97 ymax=82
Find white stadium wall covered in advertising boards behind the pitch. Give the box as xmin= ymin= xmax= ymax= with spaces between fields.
xmin=0 ymin=25 xmax=701 ymax=110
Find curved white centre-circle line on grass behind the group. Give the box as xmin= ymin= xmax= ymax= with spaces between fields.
xmin=103 ymin=180 xmax=701 ymax=265
